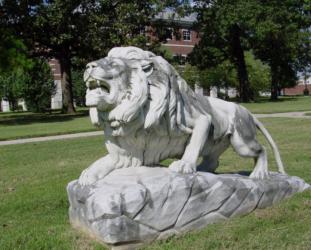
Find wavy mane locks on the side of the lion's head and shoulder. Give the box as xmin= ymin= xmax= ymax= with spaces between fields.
xmin=108 ymin=47 xmax=224 ymax=137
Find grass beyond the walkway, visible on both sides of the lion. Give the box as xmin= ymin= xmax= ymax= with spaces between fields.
xmin=0 ymin=97 xmax=311 ymax=141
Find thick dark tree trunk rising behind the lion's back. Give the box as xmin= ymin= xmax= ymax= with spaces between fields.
xmin=231 ymin=25 xmax=254 ymax=102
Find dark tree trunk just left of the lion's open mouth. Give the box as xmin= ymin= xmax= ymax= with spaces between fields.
xmin=59 ymin=53 xmax=76 ymax=114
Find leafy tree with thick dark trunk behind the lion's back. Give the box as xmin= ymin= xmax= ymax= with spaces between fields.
xmin=191 ymin=0 xmax=257 ymax=102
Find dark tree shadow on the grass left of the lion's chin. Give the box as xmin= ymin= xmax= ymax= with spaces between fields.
xmin=0 ymin=110 xmax=88 ymax=126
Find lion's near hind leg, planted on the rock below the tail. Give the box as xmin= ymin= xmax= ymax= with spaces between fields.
xmin=230 ymin=131 xmax=269 ymax=179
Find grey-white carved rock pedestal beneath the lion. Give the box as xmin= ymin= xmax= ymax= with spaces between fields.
xmin=67 ymin=167 xmax=310 ymax=248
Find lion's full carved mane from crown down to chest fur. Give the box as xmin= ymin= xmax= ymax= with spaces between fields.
xmin=85 ymin=47 xmax=225 ymax=168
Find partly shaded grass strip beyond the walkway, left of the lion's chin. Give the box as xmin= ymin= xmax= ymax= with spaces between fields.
xmin=0 ymin=110 xmax=95 ymax=141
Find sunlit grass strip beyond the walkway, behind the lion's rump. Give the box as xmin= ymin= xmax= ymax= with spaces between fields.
xmin=241 ymin=96 xmax=311 ymax=114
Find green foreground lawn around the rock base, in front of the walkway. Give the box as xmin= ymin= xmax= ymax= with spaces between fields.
xmin=0 ymin=118 xmax=311 ymax=250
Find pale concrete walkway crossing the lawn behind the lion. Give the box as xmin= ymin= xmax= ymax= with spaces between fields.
xmin=0 ymin=111 xmax=311 ymax=146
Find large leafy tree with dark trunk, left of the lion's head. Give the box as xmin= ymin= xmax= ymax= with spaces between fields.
xmin=0 ymin=0 xmax=183 ymax=113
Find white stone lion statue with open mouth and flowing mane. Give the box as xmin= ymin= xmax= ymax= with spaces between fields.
xmin=79 ymin=47 xmax=285 ymax=185
